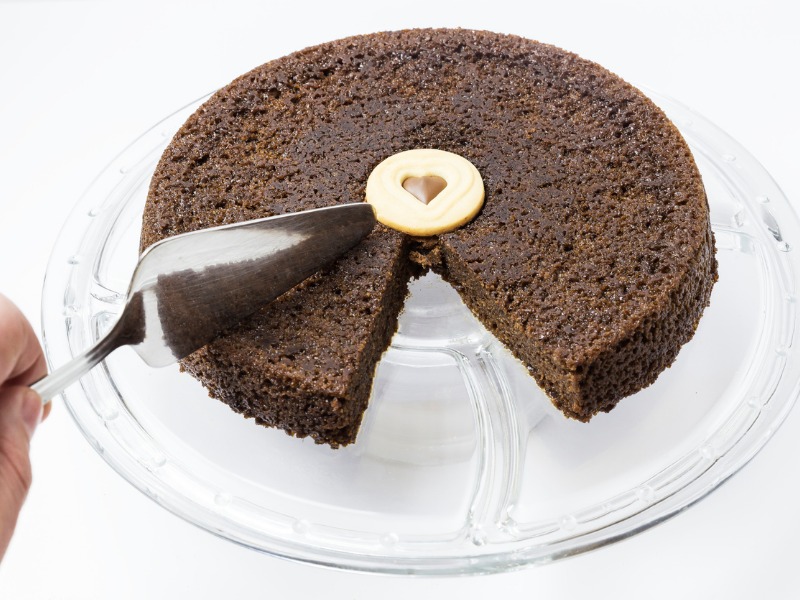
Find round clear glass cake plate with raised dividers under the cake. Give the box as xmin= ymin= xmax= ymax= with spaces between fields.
xmin=42 ymin=89 xmax=800 ymax=575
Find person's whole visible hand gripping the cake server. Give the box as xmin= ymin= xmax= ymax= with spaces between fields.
xmin=0 ymin=294 xmax=50 ymax=560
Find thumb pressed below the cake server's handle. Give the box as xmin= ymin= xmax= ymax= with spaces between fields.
xmin=0 ymin=386 xmax=42 ymax=558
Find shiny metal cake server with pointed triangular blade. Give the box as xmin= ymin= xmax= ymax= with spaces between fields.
xmin=31 ymin=203 xmax=375 ymax=403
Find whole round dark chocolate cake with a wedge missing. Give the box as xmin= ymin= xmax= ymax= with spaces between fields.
xmin=142 ymin=30 xmax=716 ymax=447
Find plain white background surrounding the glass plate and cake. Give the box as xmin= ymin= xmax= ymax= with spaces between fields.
xmin=0 ymin=0 xmax=800 ymax=600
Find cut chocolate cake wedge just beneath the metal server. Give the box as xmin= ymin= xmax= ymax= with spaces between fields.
xmin=181 ymin=229 xmax=410 ymax=447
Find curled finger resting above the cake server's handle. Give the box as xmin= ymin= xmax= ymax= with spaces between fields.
xmin=0 ymin=294 xmax=47 ymax=385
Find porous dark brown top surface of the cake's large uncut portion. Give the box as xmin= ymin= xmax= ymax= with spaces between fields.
xmin=142 ymin=30 xmax=708 ymax=372
